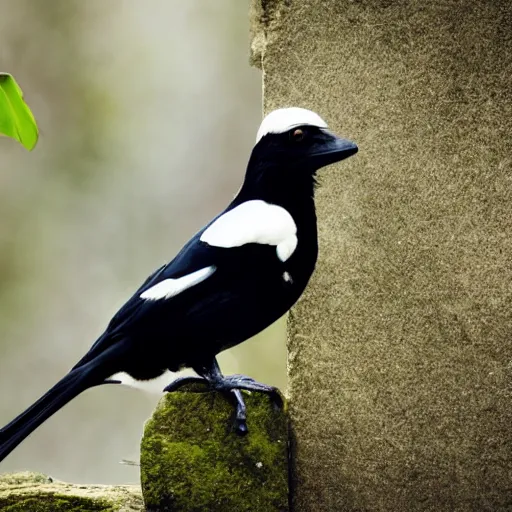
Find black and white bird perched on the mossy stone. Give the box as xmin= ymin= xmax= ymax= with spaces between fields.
xmin=0 ymin=107 xmax=358 ymax=461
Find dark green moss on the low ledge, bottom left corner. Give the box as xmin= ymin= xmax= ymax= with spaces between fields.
xmin=0 ymin=492 xmax=115 ymax=512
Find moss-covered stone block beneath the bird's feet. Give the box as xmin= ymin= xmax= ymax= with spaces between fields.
xmin=141 ymin=392 xmax=288 ymax=512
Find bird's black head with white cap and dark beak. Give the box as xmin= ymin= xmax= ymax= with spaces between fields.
xmin=246 ymin=107 xmax=357 ymax=198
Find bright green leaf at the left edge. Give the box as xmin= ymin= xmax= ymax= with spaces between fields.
xmin=0 ymin=73 xmax=38 ymax=151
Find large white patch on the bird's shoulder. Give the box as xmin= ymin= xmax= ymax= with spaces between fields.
xmin=201 ymin=199 xmax=297 ymax=261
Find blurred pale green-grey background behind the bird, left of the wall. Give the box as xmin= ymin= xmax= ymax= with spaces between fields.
xmin=0 ymin=0 xmax=286 ymax=483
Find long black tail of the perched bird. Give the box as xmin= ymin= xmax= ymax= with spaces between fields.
xmin=0 ymin=347 xmax=119 ymax=461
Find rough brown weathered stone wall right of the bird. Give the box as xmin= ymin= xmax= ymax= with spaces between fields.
xmin=252 ymin=0 xmax=512 ymax=512
